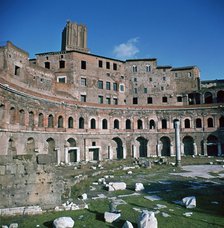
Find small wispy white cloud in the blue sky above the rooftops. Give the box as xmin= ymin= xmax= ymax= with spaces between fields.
xmin=113 ymin=37 xmax=139 ymax=59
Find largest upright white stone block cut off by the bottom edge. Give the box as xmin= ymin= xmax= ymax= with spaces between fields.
xmin=138 ymin=210 xmax=158 ymax=228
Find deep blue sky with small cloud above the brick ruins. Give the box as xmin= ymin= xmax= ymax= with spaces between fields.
xmin=0 ymin=0 xmax=224 ymax=80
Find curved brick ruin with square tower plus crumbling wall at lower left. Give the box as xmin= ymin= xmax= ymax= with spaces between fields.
xmin=0 ymin=22 xmax=224 ymax=207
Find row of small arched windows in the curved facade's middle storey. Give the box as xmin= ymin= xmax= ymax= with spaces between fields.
xmin=6 ymin=107 xmax=224 ymax=129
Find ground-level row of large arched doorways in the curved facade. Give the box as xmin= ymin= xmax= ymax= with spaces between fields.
xmin=8 ymin=134 xmax=224 ymax=163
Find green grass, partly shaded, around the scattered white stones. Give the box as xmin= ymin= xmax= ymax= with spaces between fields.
xmin=0 ymin=158 xmax=224 ymax=228
